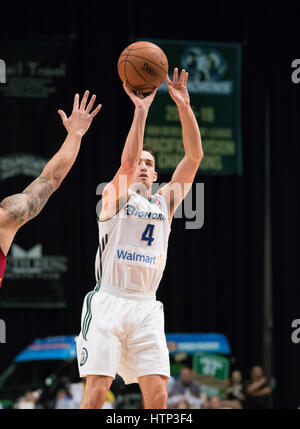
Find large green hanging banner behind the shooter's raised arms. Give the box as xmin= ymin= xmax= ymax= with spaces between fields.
xmin=143 ymin=39 xmax=242 ymax=175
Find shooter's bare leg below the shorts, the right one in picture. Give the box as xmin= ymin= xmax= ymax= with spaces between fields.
xmin=138 ymin=375 xmax=169 ymax=409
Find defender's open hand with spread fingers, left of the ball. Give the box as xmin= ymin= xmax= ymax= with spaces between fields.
xmin=58 ymin=91 xmax=102 ymax=136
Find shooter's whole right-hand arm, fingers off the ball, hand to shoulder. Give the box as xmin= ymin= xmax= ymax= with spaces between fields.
xmin=159 ymin=68 xmax=204 ymax=220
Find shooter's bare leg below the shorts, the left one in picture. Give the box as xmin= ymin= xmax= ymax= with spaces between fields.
xmin=79 ymin=375 xmax=113 ymax=409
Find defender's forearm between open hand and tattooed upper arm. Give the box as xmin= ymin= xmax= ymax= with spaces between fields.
xmin=41 ymin=133 xmax=82 ymax=191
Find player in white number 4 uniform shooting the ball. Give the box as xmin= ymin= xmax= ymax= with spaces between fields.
xmin=77 ymin=68 xmax=203 ymax=409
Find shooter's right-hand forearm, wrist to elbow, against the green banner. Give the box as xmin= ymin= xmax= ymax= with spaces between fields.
xmin=178 ymin=104 xmax=203 ymax=164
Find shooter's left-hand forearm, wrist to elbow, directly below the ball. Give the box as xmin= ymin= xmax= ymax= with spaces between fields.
xmin=121 ymin=108 xmax=148 ymax=170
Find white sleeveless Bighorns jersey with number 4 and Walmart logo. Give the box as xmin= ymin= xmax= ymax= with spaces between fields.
xmin=95 ymin=191 xmax=170 ymax=293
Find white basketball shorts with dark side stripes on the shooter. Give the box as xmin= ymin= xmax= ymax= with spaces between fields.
xmin=76 ymin=286 xmax=170 ymax=384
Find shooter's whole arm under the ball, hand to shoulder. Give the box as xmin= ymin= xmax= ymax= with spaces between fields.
xmin=100 ymin=82 xmax=157 ymax=220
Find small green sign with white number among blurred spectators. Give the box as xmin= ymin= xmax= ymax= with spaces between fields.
xmin=193 ymin=352 xmax=230 ymax=399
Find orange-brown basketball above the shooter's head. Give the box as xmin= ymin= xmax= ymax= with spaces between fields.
xmin=118 ymin=42 xmax=169 ymax=92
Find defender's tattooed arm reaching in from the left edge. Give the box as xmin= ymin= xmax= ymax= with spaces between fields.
xmin=0 ymin=91 xmax=101 ymax=287
